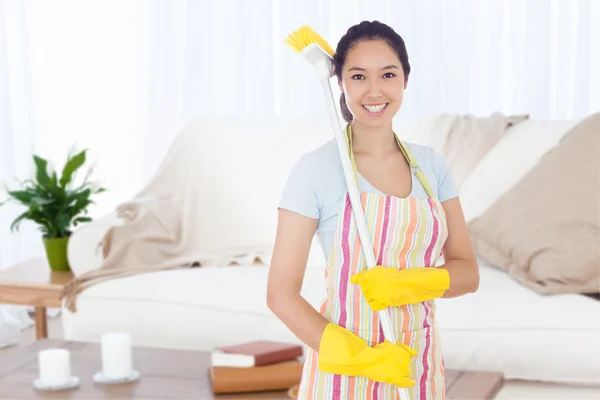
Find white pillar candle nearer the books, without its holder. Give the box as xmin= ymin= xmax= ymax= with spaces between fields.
xmin=102 ymin=332 xmax=133 ymax=380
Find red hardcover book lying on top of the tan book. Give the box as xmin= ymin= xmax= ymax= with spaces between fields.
xmin=211 ymin=340 xmax=303 ymax=367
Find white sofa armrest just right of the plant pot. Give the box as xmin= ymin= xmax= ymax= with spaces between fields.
xmin=67 ymin=211 xmax=121 ymax=276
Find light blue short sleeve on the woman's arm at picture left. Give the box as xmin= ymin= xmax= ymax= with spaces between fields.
xmin=279 ymin=154 xmax=323 ymax=219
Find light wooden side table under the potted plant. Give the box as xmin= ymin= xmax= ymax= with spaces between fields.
xmin=0 ymin=258 xmax=73 ymax=340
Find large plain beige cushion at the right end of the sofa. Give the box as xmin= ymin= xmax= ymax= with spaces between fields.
xmin=469 ymin=113 xmax=600 ymax=294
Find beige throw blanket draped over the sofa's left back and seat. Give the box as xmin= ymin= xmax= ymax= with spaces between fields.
xmin=63 ymin=122 xmax=270 ymax=312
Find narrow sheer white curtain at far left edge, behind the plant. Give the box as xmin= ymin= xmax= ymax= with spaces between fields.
xmin=0 ymin=1 xmax=36 ymax=348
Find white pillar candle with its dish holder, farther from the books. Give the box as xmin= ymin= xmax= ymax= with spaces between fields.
xmin=33 ymin=349 xmax=79 ymax=391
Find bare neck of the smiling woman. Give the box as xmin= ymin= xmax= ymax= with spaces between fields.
xmin=351 ymin=121 xmax=398 ymax=155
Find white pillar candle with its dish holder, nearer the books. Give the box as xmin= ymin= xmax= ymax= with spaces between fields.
xmin=92 ymin=332 xmax=140 ymax=385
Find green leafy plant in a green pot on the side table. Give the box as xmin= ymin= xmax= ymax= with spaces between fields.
xmin=0 ymin=150 xmax=105 ymax=271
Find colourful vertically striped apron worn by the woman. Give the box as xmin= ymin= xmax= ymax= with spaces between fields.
xmin=298 ymin=135 xmax=448 ymax=400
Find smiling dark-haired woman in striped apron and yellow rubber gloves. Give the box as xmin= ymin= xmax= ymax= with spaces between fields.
xmin=267 ymin=21 xmax=479 ymax=400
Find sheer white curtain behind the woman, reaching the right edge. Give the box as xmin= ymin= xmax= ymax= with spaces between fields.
xmin=142 ymin=0 xmax=600 ymax=170
